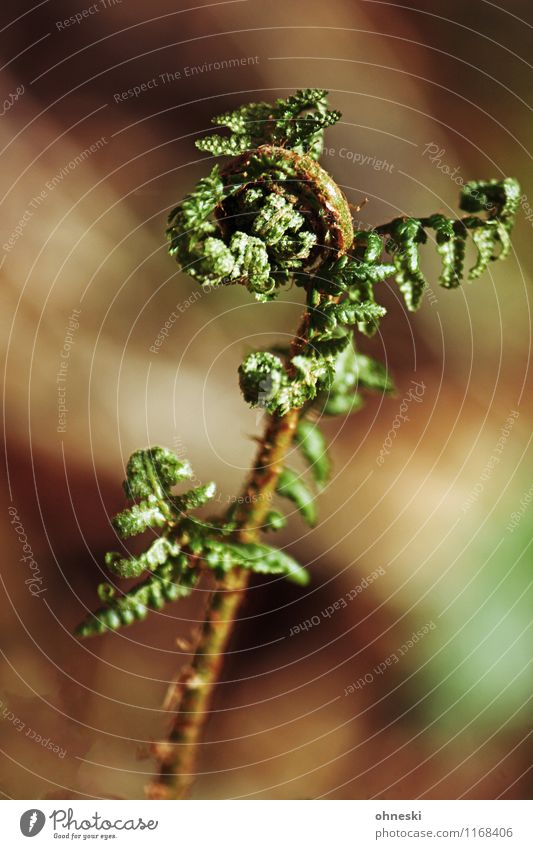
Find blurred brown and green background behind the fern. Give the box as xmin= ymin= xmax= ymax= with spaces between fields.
xmin=0 ymin=0 xmax=533 ymax=799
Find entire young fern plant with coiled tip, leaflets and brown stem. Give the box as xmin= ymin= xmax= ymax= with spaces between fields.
xmin=78 ymin=89 xmax=520 ymax=799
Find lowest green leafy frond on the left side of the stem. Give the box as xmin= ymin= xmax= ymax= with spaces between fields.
xmin=77 ymin=447 xmax=309 ymax=637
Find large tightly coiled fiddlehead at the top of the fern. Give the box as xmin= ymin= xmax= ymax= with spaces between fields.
xmin=167 ymin=90 xmax=353 ymax=301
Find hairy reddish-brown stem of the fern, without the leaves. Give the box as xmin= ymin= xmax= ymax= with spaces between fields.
xmin=147 ymin=312 xmax=309 ymax=799
